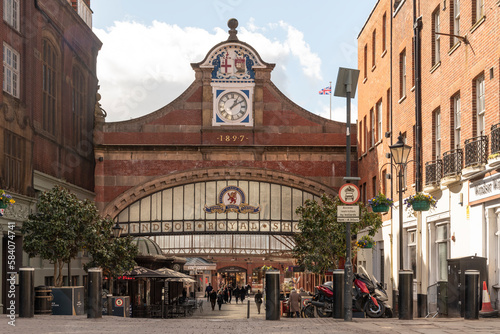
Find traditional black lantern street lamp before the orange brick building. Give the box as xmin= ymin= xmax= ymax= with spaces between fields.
xmin=389 ymin=132 xmax=411 ymax=270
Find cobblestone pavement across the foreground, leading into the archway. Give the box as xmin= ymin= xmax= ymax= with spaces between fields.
xmin=0 ymin=299 xmax=500 ymax=334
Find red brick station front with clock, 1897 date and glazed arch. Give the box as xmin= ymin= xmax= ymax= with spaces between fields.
xmin=95 ymin=20 xmax=357 ymax=291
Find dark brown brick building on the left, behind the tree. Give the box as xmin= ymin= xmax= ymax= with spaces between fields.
xmin=0 ymin=0 xmax=101 ymax=312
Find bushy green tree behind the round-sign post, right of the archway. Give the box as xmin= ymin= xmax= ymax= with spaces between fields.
xmin=293 ymin=194 xmax=382 ymax=275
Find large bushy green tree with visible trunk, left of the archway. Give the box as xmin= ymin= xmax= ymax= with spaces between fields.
xmin=21 ymin=186 xmax=136 ymax=286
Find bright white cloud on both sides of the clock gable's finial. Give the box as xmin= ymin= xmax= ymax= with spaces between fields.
xmin=94 ymin=20 xmax=322 ymax=122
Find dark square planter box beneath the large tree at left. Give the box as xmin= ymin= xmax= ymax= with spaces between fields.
xmin=52 ymin=286 xmax=85 ymax=315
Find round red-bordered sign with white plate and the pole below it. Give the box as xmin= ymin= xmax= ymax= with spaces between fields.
xmin=337 ymin=183 xmax=360 ymax=321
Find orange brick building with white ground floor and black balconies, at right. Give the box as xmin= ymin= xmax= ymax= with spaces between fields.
xmin=358 ymin=0 xmax=500 ymax=315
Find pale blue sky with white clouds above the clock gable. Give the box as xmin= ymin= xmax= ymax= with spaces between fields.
xmin=91 ymin=0 xmax=377 ymax=122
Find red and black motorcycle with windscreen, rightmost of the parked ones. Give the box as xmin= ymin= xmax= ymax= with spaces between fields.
xmin=353 ymin=266 xmax=392 ymax=318
